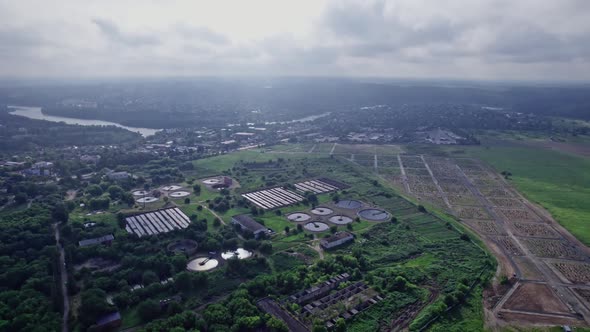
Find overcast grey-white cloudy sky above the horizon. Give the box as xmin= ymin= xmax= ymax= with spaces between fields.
xmin=0 ymin=0 xmax=590 ymax=80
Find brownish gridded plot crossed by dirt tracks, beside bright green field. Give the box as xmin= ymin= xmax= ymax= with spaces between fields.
xmin=388 ymin=155 xmax=590 ymax=324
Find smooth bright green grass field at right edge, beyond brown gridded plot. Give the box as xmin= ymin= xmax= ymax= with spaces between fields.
xmin=465 ymin=145 xmax=590 ymax=245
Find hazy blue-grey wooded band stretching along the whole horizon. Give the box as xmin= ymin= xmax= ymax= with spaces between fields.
xmin=0 ymin=79 xmax=590 ymax=128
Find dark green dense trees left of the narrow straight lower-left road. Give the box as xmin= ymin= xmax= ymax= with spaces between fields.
xmin=0 ymin=202 xmax=62 ymax=332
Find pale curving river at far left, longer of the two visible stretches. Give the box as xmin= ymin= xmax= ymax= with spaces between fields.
xmin=8 ymin=106 xmax=161 ymax=137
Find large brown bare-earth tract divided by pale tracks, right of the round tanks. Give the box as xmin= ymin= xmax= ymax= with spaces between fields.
xmin=380 ymin=155 xmax=590 ymax=329
